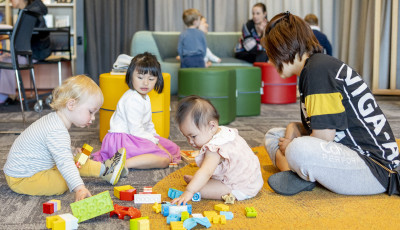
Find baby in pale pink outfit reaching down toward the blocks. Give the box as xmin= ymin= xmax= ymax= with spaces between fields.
xmin=172 ymin=96 xmax=264 ymax=205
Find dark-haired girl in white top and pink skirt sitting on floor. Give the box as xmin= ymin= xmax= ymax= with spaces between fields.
xmin=93 ymin=52 xmax=181 ymax=169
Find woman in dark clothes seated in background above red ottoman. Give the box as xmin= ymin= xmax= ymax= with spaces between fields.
xmin=235 ymin=2 xmax=268 ymax=63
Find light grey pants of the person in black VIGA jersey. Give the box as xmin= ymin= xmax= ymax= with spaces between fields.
xmin=264 ymin=128 xmax=386 ymax=195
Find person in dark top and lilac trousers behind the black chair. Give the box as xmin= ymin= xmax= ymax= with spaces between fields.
xmin=0 ymin=0 xmax=51 ymax=105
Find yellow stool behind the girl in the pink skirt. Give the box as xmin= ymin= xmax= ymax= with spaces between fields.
xmin=99 ymin=73 xmax=171 ymax=141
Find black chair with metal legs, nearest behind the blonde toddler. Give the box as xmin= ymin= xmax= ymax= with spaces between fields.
xmin=0 ymin=9 xmax=43 ymax=127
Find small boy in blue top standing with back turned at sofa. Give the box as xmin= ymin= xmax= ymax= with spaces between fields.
xmin=178 ymin=9 xmax=207 ymax=68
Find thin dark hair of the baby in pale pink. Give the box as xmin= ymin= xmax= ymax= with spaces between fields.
xmin=175 ymin=95 xmax=219 ymax=129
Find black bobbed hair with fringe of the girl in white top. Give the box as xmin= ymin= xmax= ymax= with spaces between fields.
xmin=125 ymin=52 xmax=164 ymax=93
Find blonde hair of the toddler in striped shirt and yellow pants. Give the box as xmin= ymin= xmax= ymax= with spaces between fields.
xmin=50 ymin=75 xmax=104 ymax=111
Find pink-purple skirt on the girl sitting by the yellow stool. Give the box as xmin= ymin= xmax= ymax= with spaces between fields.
xmin=92 ymin=133 xmax=181 ymax=163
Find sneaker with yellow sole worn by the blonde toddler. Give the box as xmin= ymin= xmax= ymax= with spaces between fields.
xmin=100 ymin=148 xmax=126 ymax=185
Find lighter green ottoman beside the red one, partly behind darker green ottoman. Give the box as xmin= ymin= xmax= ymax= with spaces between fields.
xmin=212 ymin=66 xmax=261 ymax=116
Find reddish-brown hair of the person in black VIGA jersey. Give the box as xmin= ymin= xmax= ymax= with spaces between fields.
xmin=261 ymin=11 xmax=322 ymax=73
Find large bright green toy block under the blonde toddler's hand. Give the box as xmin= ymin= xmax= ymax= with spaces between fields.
xmin=70 ymin=191 xmax=114 ymax=223
